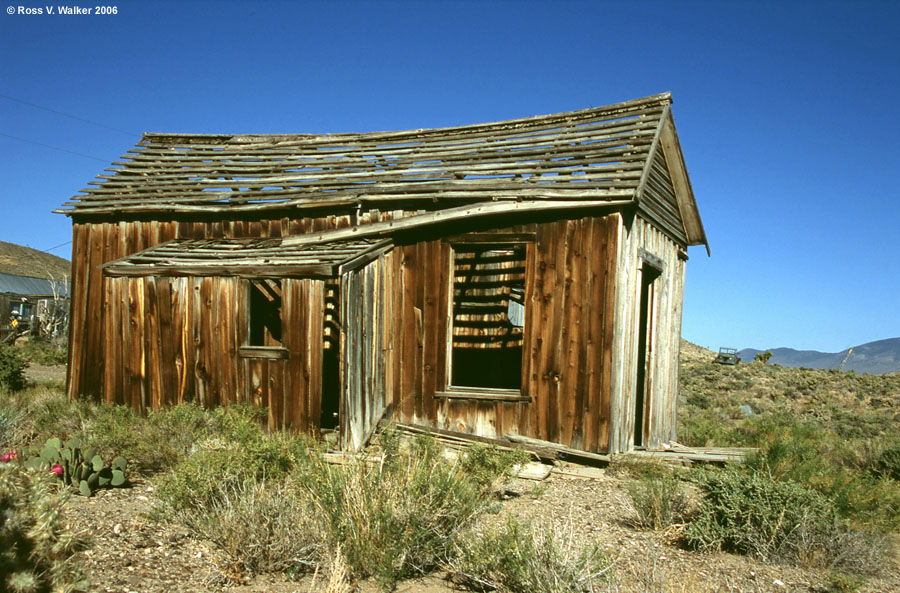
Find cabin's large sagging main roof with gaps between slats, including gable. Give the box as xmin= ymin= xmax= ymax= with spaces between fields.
xmin=57 ymin=93 xmax=706 ymax=251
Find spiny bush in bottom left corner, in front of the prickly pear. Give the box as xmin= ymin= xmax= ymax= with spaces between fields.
xmin=0 ymin=463 xmax=89 ymax=593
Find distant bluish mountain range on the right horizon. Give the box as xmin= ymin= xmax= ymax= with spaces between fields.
xmin=738 ymin=338 xmax=900 ymax=375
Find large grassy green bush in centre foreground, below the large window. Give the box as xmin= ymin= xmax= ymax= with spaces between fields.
xmin=300 ymin=433 xmax=516 ymax=588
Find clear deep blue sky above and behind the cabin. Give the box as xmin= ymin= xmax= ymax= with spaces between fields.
xmin=0 ymin=0 xmax=900 ymax=351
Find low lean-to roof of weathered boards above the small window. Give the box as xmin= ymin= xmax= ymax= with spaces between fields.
xmin=101 ymin=238 xmax=391 ymax=278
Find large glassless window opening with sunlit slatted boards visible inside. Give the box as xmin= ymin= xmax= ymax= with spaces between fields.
xmin=451 ymin=244 xmax=525 ymax=389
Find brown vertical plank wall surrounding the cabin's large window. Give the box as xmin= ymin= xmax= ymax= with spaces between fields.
xmin=372 ymin=215 xmax=620 ymax=452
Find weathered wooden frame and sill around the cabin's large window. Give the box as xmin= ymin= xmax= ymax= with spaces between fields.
xmin=434 ymin=233 xmax=535 ymax=403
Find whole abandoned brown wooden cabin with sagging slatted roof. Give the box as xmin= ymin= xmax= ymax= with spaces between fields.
xmin=59 ymin=94 xmax=706 ymax=453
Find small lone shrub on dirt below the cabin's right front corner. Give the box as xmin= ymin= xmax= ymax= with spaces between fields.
xmin=626 ymin=471 xmax=688 ymax=530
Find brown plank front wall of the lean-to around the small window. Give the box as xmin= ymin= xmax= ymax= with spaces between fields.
xmin=96 ymin=277 xmax=324 ymax=431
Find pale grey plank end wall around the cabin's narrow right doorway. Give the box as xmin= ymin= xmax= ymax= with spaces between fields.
xmin=610 ymin=216 xmax=685 ymax=453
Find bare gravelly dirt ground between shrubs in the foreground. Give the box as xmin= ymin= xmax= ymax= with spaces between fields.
xmin=67 ymin=465 xmax=900 ymax=593
